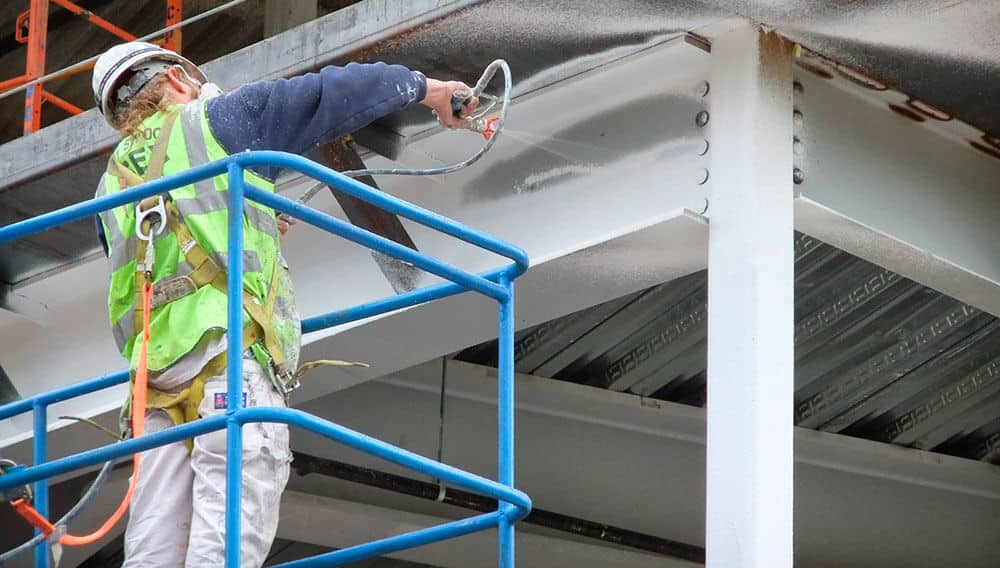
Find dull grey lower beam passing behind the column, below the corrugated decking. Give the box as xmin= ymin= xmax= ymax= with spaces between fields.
xmin=293 ymin=361 xmax=1000 ymax=568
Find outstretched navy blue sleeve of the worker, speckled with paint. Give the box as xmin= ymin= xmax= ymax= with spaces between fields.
xmin=206 ymin=63 xmax=427 ymax=180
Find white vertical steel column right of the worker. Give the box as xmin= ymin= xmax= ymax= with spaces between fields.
xmin=706 ymin=23 xmax=794 ymax=568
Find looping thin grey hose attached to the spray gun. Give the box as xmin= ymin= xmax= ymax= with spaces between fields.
xmin=298 ymin=59 xmax=511 ymax=203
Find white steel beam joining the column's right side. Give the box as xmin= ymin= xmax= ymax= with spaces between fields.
xmin=795 ymin=66 xmax=1000 ymax=315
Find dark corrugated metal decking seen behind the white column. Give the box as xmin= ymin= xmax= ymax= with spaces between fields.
xmin=456 ymin=233 xmax=1000 ymax=463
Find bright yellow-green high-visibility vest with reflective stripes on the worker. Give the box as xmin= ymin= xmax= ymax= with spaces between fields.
xmin=97 ymin=99 xmax=301 ymax=373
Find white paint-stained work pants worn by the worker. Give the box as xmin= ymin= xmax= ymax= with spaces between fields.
xmin=123 ymin=359 xmax=291 ymax=568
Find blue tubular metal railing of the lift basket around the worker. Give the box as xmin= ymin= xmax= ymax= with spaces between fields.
xmin=0 ymin=152 xmax=531 ymax=568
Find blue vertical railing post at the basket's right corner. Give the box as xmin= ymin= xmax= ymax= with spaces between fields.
xmin=497 ymin=274 xmax=514 ymax=568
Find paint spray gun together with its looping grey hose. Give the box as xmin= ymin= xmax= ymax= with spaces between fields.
xmin=298 ymin=59 xmax=511 ymax=203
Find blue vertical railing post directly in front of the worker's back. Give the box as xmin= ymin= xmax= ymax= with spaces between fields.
xmin=226 ymin=163 xmax=243 ymax=568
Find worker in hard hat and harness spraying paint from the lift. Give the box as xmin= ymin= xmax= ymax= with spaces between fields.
xmin=93 ymin=42 xmax=475 ymax=568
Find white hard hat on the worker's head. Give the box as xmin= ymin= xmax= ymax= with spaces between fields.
xmin=92 ymin=41 xmax=208 ymax=126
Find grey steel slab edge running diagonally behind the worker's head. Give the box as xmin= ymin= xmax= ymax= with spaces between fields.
xmin=0 ymin=0 xmax=482 ymax=194
